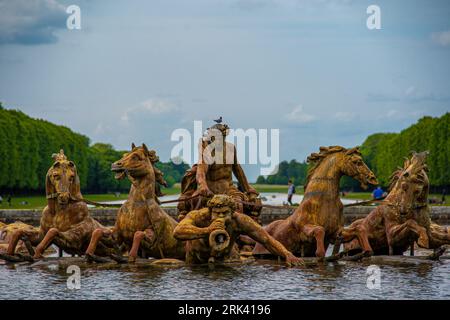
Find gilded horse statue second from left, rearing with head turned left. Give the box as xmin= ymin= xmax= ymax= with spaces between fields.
xmin=86 ymin=144 xmax=186 ymax=262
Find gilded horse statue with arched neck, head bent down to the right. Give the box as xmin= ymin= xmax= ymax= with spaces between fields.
xmin=253 ymin=146 xmax=377 ymax=258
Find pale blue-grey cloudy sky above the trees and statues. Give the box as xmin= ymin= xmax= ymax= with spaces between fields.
xmin=0 ymin=0 xmax=450 ymax=180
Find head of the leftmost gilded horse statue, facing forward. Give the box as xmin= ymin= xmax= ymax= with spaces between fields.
xmin=45 ymin=149 xmax=81 ymax=206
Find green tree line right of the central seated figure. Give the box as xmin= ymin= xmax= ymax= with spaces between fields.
xmin=257 ymin=113 xmax=450 ymax=192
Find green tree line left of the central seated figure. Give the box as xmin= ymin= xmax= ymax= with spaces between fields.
xmin=0 ymin=103 xmax=189 ymax=194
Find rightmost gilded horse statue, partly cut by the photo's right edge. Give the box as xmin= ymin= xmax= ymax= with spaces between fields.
xmin=343 ymin=152 xmax=450 ymax=255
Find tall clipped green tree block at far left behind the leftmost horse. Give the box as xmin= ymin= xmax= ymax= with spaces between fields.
xmin=0 ymin=108 xmax=89 ymax=192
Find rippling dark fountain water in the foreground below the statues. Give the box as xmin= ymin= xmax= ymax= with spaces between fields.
xmin=0 ymin=260 xmax=450 ymax=299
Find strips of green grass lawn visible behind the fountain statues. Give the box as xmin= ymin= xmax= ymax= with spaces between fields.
xmin=0 ymin=184 xmax=450 ymax=210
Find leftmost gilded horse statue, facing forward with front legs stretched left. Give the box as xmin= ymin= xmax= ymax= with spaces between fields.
xmin=3 ymin=150 xmax=102 ymax=260
